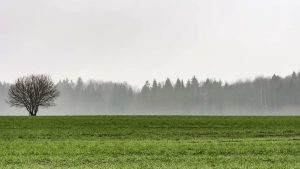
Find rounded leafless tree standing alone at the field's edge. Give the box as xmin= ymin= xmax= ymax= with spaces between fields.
xmin=8 ymin=75 xmax=59 ymax=116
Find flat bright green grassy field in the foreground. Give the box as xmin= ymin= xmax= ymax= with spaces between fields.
xmin=0 ymin=116 xmax=300 ymax=169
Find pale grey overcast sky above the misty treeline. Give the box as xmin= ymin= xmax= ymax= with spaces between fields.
xmin=0 ymin=0 xmax=300 ymax=86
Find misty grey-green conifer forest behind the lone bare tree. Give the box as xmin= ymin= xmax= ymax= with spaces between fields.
xmin=0 ymin=73 xmax=300 ymax=115
